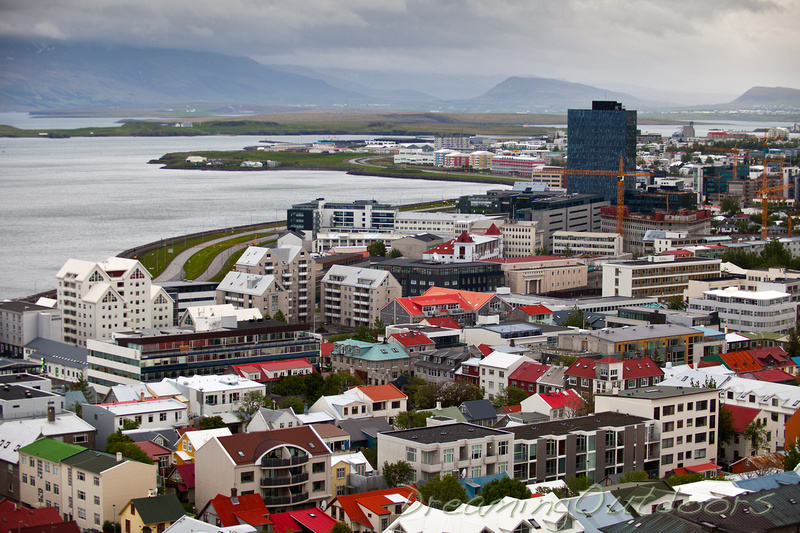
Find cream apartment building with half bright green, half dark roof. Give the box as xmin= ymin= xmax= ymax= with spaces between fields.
xmin=19 ymin=439 xmax=158 ymax=530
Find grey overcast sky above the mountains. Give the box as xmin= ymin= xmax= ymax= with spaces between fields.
xmin=0 ymin=0 xmax=800 ymax=94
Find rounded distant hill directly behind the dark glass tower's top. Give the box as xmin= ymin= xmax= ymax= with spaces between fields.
xmin=463 ymin=77 xmax=645 ymax=113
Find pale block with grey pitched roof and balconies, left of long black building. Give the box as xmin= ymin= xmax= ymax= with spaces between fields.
xmin=320 ymin=265 xmax=402 ymax=327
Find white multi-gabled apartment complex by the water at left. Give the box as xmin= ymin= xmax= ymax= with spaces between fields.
xmin=56 ymin=257 xmax=173 ymax=346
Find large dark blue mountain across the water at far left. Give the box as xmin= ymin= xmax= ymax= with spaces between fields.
xmin=0 ymin=40 xmax=363 ymax=110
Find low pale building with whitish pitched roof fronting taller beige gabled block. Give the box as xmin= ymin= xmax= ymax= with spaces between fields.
xmin=217 ymin=272 xmax=289 ymax=320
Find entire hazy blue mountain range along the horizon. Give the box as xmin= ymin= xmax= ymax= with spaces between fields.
xmin=0 ymin=39 xmax=800 ymax=113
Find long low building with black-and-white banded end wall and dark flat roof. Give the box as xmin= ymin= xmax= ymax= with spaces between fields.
xmin=87 ymin=316 xmax=319 ymax=394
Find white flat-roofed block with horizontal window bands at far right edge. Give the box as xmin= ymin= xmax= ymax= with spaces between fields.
xmin=689 ymin=287 xmax=797 ymax=333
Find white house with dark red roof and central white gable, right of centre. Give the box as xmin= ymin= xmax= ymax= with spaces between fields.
xmin=564 ymin=357 xmax=664 ymax=394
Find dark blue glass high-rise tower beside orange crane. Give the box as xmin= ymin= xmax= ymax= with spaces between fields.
xmin=567 ymin=100 xmax=636 ymax=204
